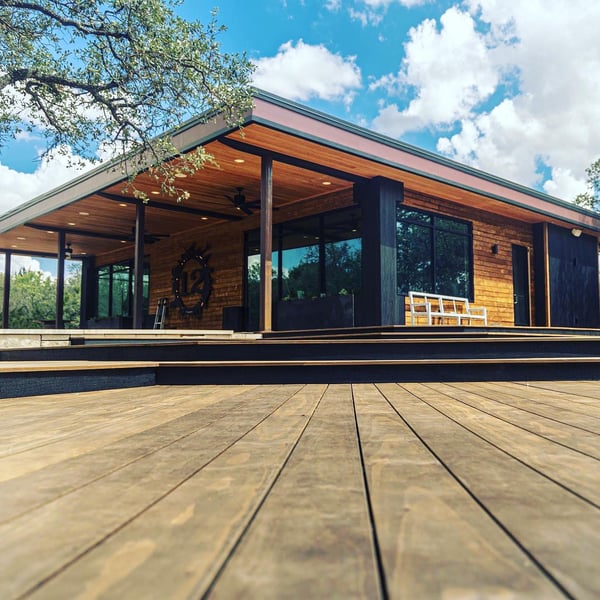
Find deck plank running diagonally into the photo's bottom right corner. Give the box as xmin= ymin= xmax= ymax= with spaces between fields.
xmin=378 ymin=384 xmax=600 ymax=598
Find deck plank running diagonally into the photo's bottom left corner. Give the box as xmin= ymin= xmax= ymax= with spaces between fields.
xmin=0 ymin=386 xmax=298 ymax=597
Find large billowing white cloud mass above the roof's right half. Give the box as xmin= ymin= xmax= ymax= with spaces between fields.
xmin=371 ymin=0 xmax=600 ymax=199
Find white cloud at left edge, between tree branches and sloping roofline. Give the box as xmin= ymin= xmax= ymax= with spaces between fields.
xmin=0 ymin=150 xmax=93 ymax=215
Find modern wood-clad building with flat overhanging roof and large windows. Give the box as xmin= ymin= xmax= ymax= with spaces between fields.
xmin=0 ymin=92 xmax=600 ymax=331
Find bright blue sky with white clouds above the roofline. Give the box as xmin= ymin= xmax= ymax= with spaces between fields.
xmin=0 ymin=0 xmax=600 ymax=272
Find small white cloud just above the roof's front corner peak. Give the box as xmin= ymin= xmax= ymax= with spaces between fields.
xmin=254 ymin=40 xmax=361 ymax=105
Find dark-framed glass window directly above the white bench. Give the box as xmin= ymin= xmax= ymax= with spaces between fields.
xmin=396 ymin=206 xmax=473 ymax=298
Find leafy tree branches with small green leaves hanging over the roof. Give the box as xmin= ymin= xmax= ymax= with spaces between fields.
xmin=0 ymin=0 xmax=252 ymax=199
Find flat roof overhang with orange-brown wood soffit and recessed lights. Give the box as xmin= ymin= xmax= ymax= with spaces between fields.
xmin=0 ymin=92 xmax=600 ymax=256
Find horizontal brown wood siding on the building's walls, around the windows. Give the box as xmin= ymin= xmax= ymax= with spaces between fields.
xmin=96 ymin=184 xmax=534 ymax=329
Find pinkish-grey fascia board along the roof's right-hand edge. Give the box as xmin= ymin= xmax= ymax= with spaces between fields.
xmin=252 ymin=92 xmax=600 ymax=231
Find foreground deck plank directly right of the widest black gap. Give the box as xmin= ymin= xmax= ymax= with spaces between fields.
xmin=354 ymin=385 xmax=562 ymax=598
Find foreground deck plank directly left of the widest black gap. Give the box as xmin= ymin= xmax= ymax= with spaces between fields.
xmin=209 ymin=385 xmax=380 ymax=598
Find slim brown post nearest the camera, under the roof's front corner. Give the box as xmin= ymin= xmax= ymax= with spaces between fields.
xmin=259 ymin=156 xmax=273 ymax=331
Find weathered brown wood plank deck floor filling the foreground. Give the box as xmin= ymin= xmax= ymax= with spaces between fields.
xmin=0 ymin=381 xmax=600 ymax=600
